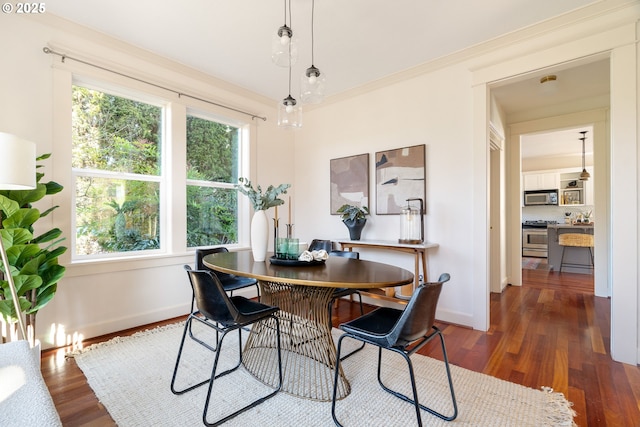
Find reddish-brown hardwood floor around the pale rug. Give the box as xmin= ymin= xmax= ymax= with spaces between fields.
xmin=42 ymin=270 xmax=640 ymax=427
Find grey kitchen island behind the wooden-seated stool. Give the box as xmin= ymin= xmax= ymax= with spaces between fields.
xmin=547 ymin=223 xmax=593 ymax=274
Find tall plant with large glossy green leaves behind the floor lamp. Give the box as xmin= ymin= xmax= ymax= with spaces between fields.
xmin=0 ymin=154 xmax=67 ymax=344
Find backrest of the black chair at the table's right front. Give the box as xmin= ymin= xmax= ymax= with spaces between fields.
xmin=387 ymin=273 xmax=451 ymax=347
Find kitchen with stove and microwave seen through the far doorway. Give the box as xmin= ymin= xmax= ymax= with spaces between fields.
xmin=520 ymin=124 xmax=597 ymax=292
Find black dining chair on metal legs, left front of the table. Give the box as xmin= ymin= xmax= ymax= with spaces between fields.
xmin=171 ymin=265 xmax=282 ymax=426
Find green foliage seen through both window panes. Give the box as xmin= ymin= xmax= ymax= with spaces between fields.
xmin=72 ymin=86 xmax=241 ymax=255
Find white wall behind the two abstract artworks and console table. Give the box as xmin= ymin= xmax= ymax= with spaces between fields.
xmin=295 ymin=66 xmax=475 ymax=325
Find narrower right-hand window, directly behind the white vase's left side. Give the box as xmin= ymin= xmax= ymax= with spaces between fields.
xmin=187 ymin=115 xmax=242 ymax=247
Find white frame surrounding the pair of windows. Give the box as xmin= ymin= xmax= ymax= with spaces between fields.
xmin=51 ymin=69 xmax=256 ymax=277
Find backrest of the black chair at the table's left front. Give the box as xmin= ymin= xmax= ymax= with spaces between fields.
xmin=184 ymin=265 xmax=239 ymax=325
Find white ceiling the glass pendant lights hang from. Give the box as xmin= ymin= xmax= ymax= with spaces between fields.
xmin=46 ymin=0 xmax=597 ymax=101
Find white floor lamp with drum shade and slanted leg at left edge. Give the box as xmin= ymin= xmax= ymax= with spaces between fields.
xmin=0 ymin=132 xmax=36 ymax=339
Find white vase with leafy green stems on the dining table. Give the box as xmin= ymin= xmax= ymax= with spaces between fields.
xmin=236 ymin=178 xmax=291 ymax=262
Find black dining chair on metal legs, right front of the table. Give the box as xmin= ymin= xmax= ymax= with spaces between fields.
xmin=331 ymin=273 xmax=458 ymax=426
